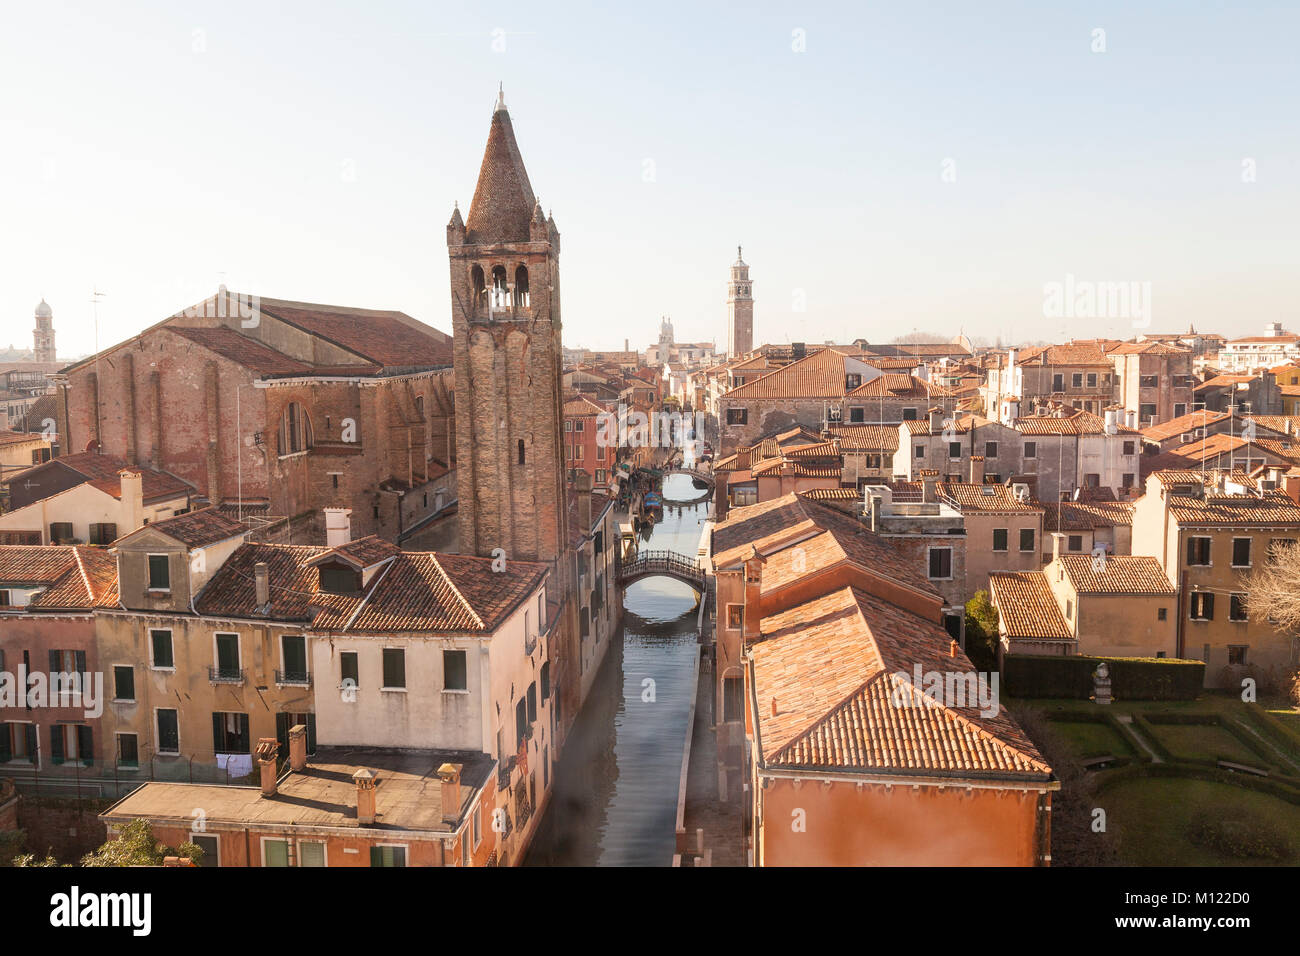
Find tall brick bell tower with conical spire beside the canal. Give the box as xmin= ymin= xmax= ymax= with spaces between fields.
xmin=447 ymin=87 xmax=568 ymax=567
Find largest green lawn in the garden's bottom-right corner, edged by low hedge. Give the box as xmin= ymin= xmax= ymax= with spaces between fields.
xmin=1097 ymin=778 xmax=1300 ymax=866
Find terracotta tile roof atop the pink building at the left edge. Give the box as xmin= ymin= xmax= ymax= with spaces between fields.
xmin=0 ymin=545 xmax=117 ymax=611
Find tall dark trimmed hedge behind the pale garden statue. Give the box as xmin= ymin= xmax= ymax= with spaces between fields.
xmin=1002 ymin=654 xmax=1205 ymax=700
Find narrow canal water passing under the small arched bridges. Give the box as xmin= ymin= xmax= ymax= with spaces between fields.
xmin=525 ymin=475 xmax=709 ymax=866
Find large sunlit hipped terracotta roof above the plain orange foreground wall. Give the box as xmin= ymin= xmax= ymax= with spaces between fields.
xmin=753 ymin=588 xmax=1052 ymax=779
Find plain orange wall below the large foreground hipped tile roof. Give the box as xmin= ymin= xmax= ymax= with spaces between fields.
xmin=758 ymin=779 xmax=1040 ymax=866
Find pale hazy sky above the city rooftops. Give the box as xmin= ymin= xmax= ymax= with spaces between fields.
xmin=0 ymin=0 xmax=1300 ymax=356
